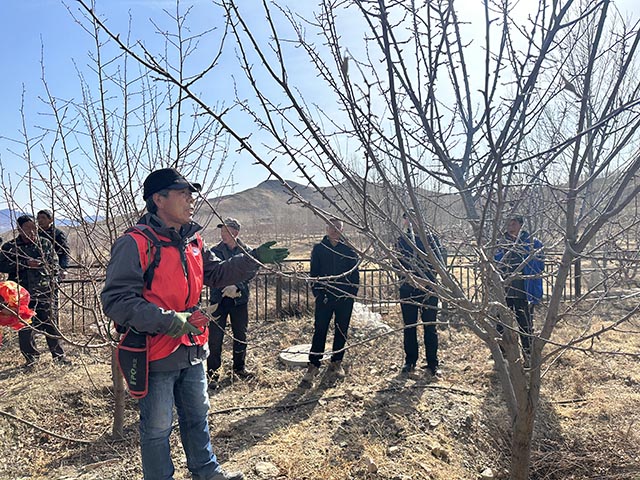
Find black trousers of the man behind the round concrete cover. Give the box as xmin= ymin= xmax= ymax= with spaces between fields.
xmin=309 ymin=296 xmax=353 ymax=367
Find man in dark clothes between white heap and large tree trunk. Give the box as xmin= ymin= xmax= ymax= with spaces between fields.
xmin=396 ymin=210 xmax=443 ymax=377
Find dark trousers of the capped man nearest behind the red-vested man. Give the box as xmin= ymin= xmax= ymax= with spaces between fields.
xmin=207 ymin=299 xmax=249 ymax=372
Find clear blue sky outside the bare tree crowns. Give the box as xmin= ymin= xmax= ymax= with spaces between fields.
xmin=0 ymin=0 xmax=640 ymax=212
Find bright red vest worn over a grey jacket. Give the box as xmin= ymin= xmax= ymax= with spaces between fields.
xmin=128 ymin=225 xmax=209 ymax=362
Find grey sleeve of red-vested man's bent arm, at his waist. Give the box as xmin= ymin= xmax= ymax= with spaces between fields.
xmin=100 ymin=235 xmax=179 ymax=333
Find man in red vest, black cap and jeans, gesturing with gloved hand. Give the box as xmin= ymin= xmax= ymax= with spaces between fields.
xmin=101 ymin=168 xmax=288 ymax=480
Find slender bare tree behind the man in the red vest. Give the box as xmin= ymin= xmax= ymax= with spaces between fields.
xmin=4 ymin=3 xmax=234 ymax=436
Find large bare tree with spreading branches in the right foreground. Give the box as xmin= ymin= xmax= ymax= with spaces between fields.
xmin=33 ymin=0 xmax=640 ymax=480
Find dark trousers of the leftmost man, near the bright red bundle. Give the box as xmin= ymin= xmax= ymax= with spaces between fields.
xmin=18 ymin=300 xmax=64 ymax=362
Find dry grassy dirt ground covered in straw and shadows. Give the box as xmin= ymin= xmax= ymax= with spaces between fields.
xmin=0 ymin=304 xmax=640 ymax=480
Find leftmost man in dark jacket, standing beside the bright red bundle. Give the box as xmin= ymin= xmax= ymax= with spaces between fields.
xmin=0 ymin=215 xmax=70 ymax=367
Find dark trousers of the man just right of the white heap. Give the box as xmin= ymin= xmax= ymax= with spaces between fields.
xmin=400 ymin=294 xmax=438 ymax=371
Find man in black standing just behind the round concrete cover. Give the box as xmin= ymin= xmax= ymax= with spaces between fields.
xmin=302 ymin=218 xmax=360 ymax=385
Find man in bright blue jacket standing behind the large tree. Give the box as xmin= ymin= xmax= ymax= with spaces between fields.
xmin=495 ymin=216 xmax=544 ymax=358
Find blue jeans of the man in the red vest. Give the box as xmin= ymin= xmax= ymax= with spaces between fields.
xmin=139 ymin=363 xmax=220 ymax=480
